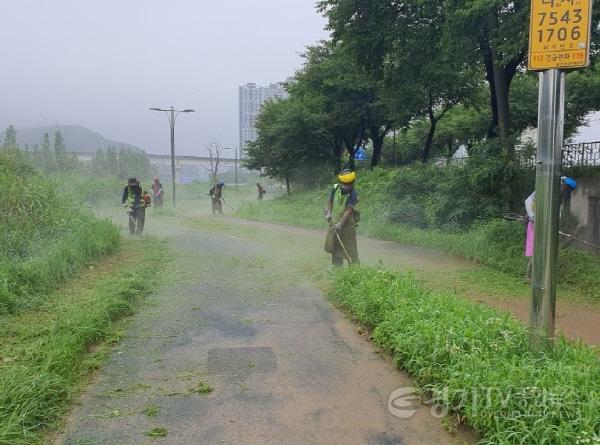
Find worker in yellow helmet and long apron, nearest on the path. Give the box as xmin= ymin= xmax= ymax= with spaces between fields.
xmin=325 ymin=170 xmax=360 ymax=267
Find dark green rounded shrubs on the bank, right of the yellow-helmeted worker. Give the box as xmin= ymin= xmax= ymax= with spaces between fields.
xmin=386 ymin=152 xmax=533 ymax=230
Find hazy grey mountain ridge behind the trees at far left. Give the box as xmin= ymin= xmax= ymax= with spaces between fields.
xmin=0 ymin=125 xmax=141 ymax=153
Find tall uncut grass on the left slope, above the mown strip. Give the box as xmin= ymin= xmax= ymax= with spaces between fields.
xmin=0 ymin=150 xmax=119 ymax=315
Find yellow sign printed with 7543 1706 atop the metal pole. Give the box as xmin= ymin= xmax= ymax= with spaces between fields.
xmin=529 ymin=0 xmax=592 ymax=71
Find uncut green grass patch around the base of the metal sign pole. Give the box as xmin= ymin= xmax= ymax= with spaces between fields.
xmin=331 ymin=268 xmax=600 ymax=445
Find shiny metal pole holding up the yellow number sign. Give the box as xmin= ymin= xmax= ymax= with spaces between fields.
xmin=529 ymin=69 xmax=565 ymax=350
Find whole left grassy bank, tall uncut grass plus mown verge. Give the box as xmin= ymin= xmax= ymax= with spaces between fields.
xmin=0 ymin=152 xmax=165 ymax=445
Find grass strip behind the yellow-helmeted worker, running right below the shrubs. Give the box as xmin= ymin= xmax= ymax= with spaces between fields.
xmin=237 ymin=170 xmax=600 ymax=298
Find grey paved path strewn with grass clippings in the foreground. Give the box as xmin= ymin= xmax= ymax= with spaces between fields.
xmin=55 ymin=209 xmax=470 ymax=445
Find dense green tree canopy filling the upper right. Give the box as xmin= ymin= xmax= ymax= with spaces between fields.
xmin=247 ymin=0 xmax=600 ymax=191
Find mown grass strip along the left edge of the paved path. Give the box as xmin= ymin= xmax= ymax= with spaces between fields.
xmin=0 ymin=239 xmax=164 ymax=445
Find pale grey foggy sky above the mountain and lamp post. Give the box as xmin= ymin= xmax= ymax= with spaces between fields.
xmin=0 ymin=0 xmax=328 ymax=155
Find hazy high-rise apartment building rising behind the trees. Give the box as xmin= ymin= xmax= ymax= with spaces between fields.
xmin=239 ymin=83 xmax=288 ymax=158
